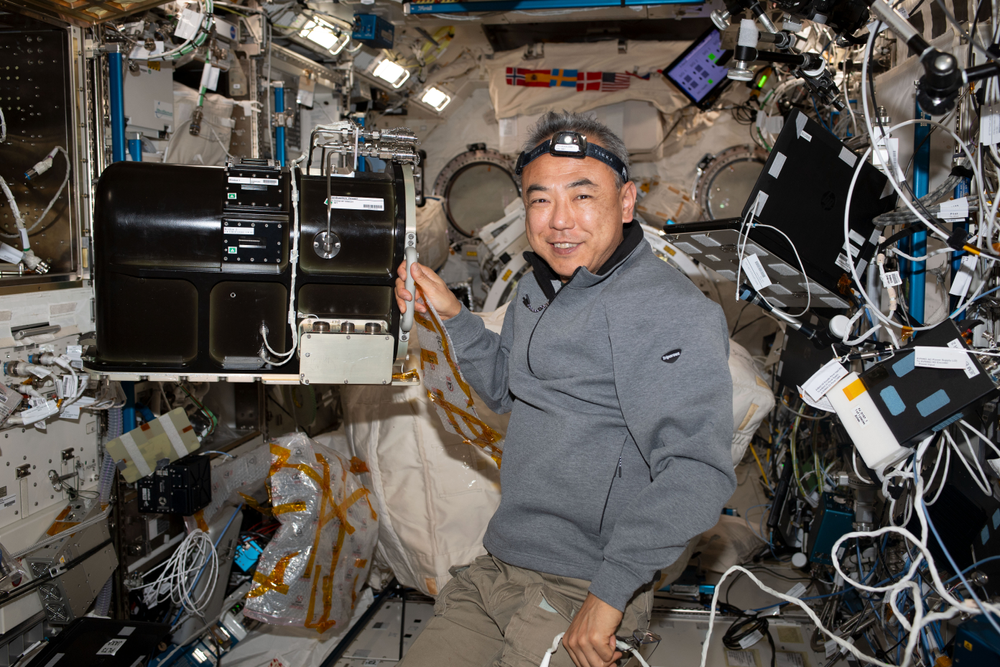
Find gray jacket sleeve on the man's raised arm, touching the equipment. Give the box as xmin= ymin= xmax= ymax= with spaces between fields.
xmin=444 ymin=306 xmax=516 ymax=414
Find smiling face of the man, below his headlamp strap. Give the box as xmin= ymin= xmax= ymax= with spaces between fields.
xmin=521 ymin=143 xmax=636 ymax=280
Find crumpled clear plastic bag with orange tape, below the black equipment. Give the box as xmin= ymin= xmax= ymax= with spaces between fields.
xmin=244 ymin=433 xmax=378 ymax=633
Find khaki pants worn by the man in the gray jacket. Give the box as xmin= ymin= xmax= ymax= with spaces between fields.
xmin=399 ymin=556 xmax=653 ymax=667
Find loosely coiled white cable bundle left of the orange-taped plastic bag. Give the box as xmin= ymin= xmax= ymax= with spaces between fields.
xmin=135 ymin=530 xmax=219 ymax=616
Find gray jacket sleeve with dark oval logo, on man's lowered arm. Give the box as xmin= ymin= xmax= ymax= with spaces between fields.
xmin=590 ymin=293 xmax=736 ymax=611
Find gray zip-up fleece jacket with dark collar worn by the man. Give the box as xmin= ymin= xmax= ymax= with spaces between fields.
xmin=446 ymin=223 xmax=736 ymax=611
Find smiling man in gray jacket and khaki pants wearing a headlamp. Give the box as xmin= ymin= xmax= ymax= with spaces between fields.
xmin=396 ymin=113 xmax=735 ymax=667
